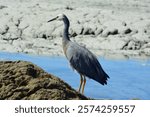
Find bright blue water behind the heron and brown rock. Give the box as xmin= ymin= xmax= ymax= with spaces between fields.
xmin=0 ymin=52 xmax=150 ymax=100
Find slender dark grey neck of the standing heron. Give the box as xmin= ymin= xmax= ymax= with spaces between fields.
xmin=63 ymin=17 xmax=70 ymax=41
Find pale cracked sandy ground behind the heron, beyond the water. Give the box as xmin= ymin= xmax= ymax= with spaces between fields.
xmin=0 ymin=0 xmax=150 ymax=58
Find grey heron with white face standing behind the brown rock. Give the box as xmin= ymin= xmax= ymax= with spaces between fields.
xmin=48 ymin=14 xmax=109 ymax=94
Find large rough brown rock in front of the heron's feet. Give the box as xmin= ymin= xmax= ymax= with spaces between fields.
xmin=0 ymin=61 xmax=88 ymax=100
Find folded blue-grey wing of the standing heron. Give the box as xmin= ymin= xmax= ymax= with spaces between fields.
xmin=66 ymin=42 xmax=109 ymax=85
